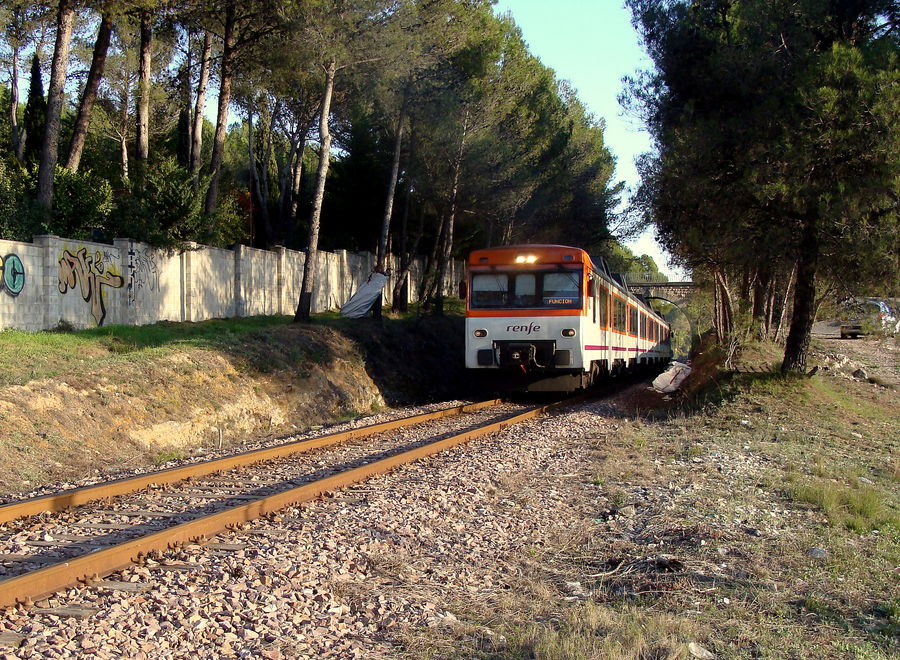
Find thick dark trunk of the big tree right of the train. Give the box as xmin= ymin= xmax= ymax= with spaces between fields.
xmin=781 ymin=214 xmax=819 ymax=371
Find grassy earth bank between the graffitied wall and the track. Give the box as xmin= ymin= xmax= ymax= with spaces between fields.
xmin=0 ymin=316 xmax=462 ymax=495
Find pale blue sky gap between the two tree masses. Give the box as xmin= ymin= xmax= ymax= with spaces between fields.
xmin=494 ymin=0 xmax=684 ymax=279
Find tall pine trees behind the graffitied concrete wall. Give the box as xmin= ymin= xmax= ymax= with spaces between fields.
xmin=0 ymin=0 xmax=621 ymax=312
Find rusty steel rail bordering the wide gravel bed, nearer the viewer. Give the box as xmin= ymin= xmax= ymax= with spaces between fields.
xmin=0 ymin=395 xmax=584 ymax=608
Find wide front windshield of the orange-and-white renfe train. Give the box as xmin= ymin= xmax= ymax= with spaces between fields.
xmin=469 ymin=269 xmax=581 ymax=309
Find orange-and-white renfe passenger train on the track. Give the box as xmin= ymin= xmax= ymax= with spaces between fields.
xmin=465 ymin=245 xmax=672 ymax=392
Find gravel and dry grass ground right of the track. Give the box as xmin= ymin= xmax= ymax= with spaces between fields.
xmin=0 ymin=330 xmax=900 ymax=660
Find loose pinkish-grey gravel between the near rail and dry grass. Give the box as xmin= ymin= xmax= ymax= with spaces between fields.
xmin=0 ymin=394 xmax=620 ymax=658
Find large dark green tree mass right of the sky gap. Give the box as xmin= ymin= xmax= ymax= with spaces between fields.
xmin=624 ymin=0 xmax=900 ymax=369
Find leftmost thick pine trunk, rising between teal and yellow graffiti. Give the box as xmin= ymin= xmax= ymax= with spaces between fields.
xmin=37 ymin=0 xmax=75 ymax=210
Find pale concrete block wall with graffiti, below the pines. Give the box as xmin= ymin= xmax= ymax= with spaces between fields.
xmin=0 ymin=236 xmax=464 ymax=331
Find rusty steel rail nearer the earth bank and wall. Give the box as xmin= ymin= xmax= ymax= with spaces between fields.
xmin=0 ymin=399 xmax=503 ymax=523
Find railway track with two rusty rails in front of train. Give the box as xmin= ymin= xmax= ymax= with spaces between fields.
xmin=0 ymin=399 xmax=584 ymax=608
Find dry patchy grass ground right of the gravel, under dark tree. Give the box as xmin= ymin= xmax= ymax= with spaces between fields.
xmin=407 ymin=346 xmax=900 ymax=660
